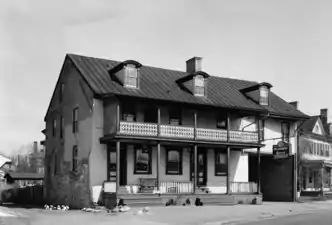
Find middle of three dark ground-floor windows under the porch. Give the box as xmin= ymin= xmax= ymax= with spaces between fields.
xmin=166 ymin=149 xmax=182 ymax=175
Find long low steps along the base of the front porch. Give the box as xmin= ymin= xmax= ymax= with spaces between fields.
xmin=119 ymin=194 xmax=236 ymax=207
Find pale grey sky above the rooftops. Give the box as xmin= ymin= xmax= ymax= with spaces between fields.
xmin=0 ymin=0 xmax=332 ymax=154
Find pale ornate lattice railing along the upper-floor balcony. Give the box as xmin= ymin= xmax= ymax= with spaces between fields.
xmin=119 ymin=121 xmax=258 ymax=143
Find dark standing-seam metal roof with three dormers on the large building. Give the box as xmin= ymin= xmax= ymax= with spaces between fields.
xmin=56 ymin=54 xmax=308 ymax=119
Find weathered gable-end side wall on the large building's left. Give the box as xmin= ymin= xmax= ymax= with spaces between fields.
xmin=45 ymin=60 xmax=93 ymax=208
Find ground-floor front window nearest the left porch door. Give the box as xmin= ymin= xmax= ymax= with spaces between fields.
xmin=134 ymin=146 xmax=152 ymax=174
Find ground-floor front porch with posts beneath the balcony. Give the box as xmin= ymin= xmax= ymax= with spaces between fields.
xmin=100 ymin=141 xmax=260 ymax=204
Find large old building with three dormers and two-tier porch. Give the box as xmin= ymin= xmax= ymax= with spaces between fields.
xmin=44 ymin=54 xmax=307 ymax=207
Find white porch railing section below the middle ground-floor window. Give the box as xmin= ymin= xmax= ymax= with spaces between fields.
xmin=160 ymin=181 xmax=193 ymax=193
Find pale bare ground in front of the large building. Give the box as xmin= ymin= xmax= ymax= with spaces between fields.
xmin=0 ymin=202 xmax=332 ymax=225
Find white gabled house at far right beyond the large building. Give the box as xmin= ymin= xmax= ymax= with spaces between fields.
xmin=298 ymin=109 xmax=332 ymax=197
